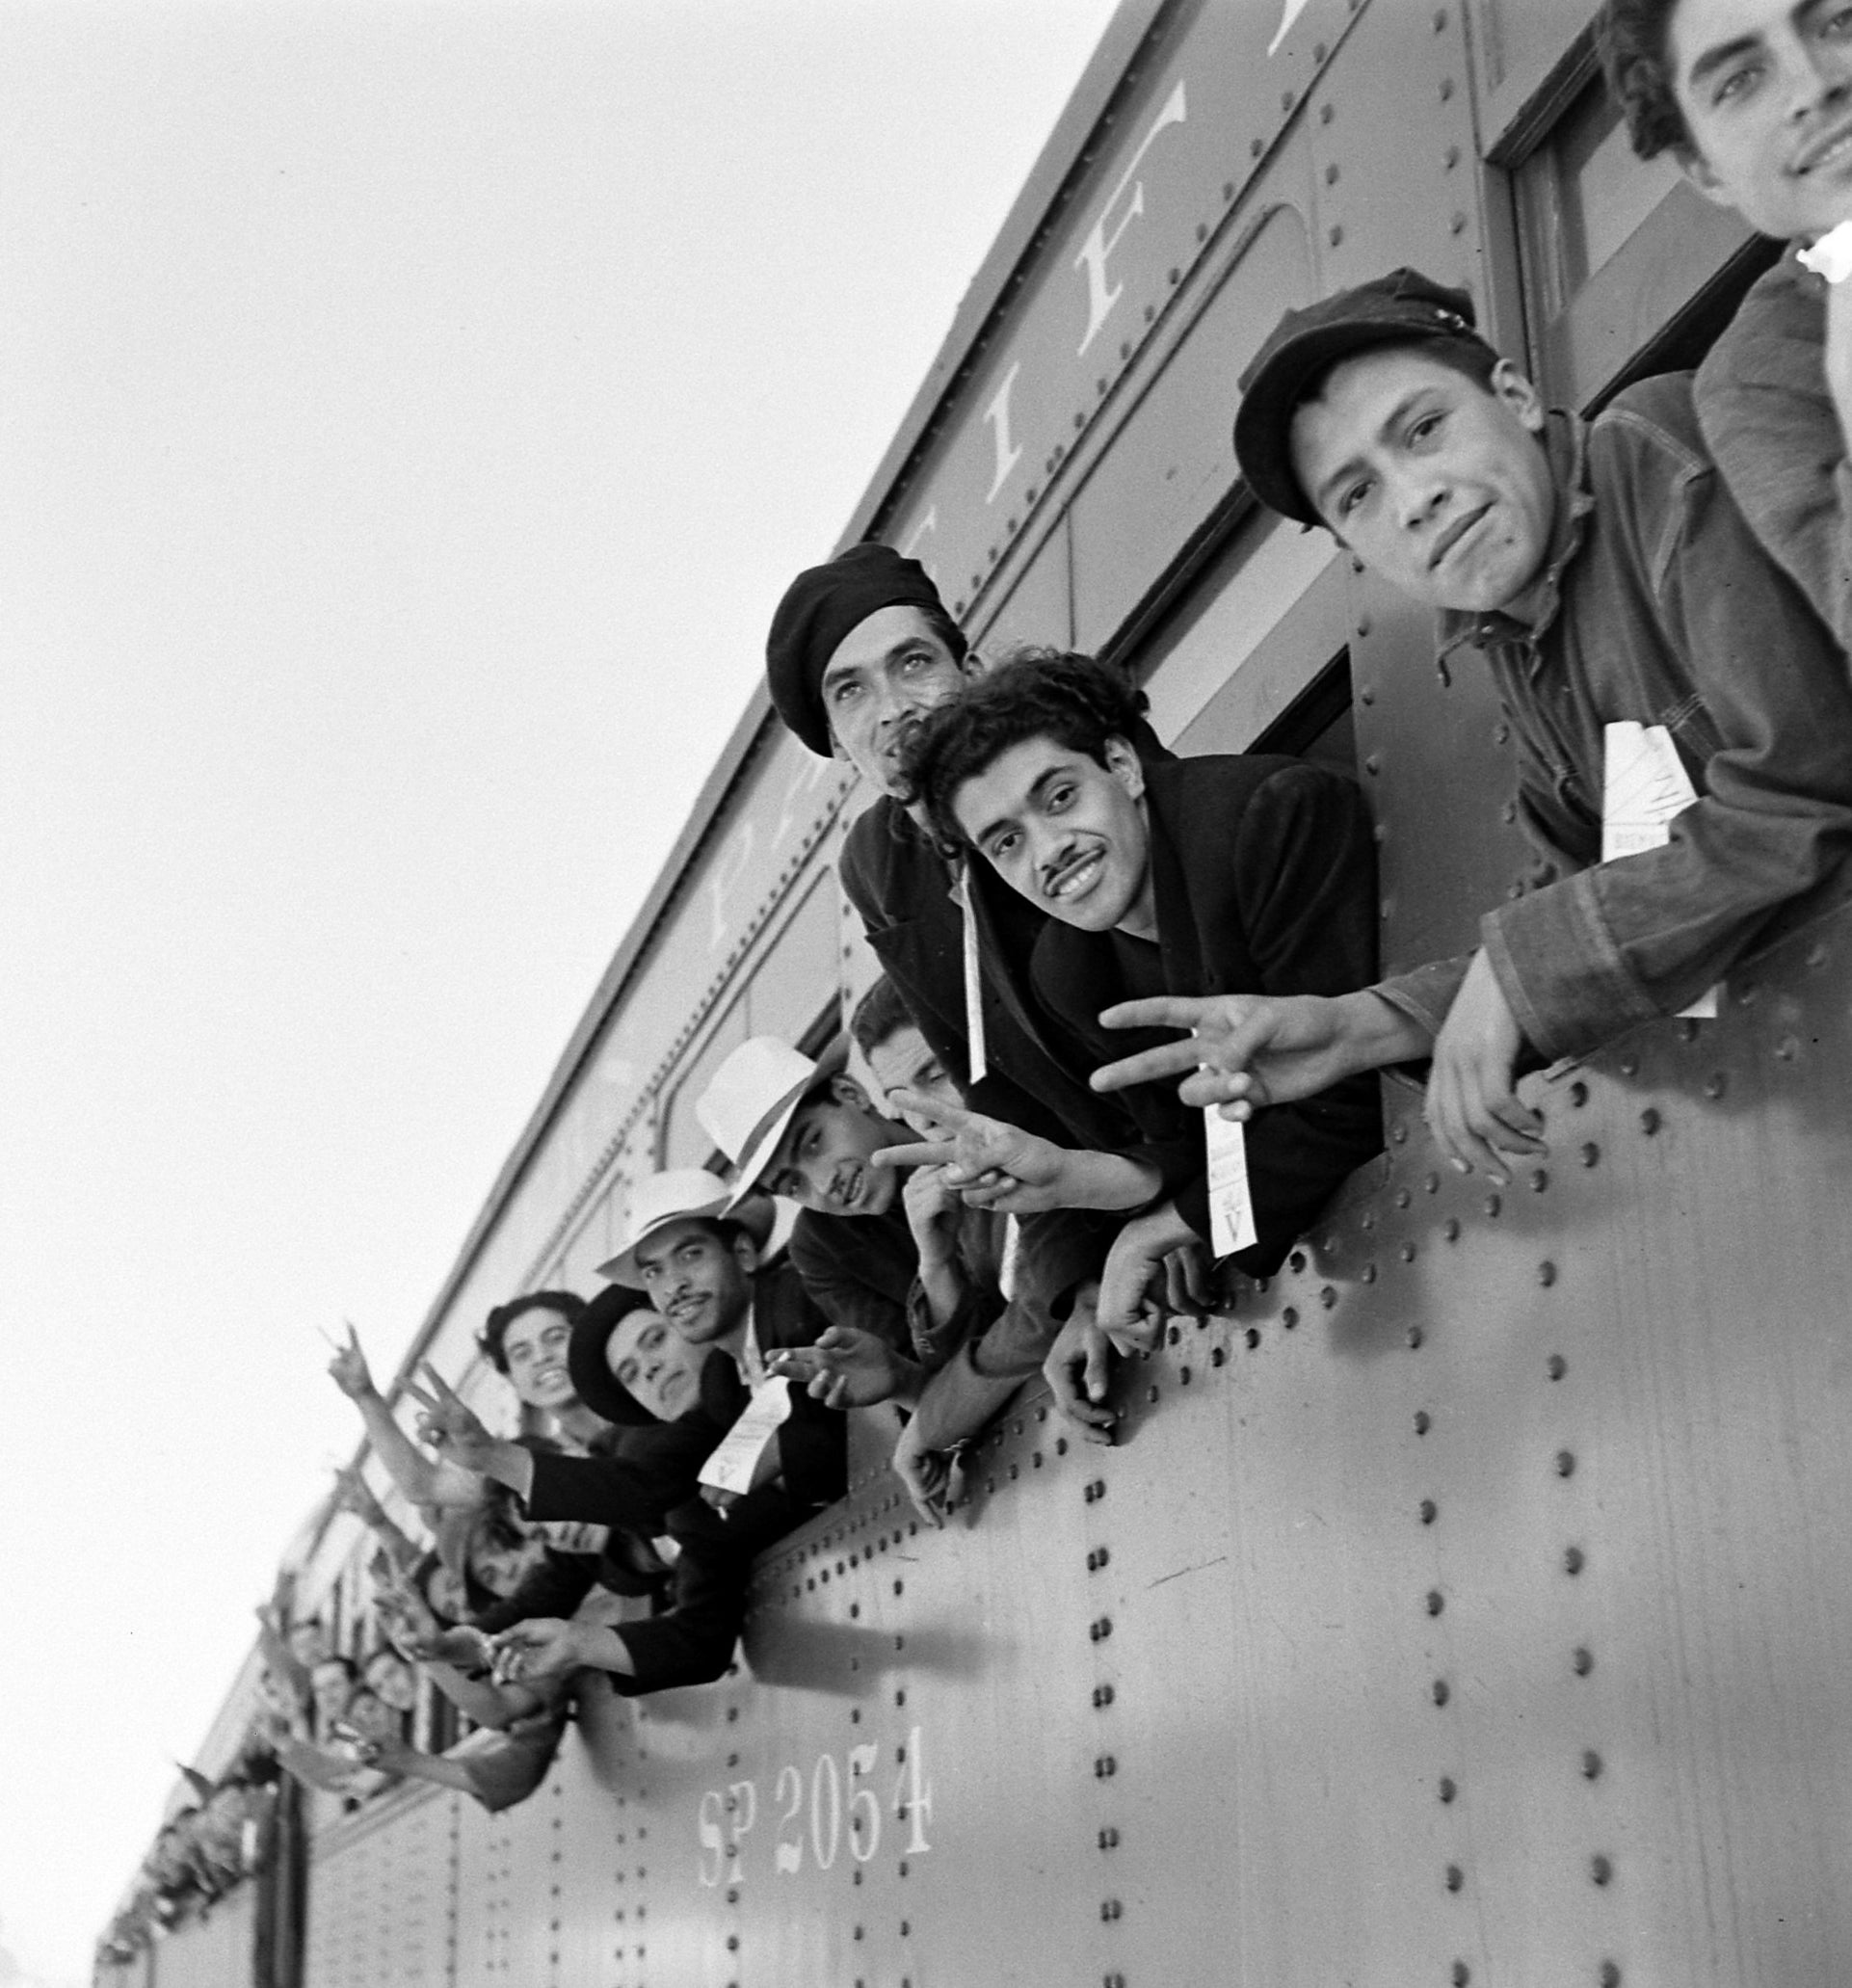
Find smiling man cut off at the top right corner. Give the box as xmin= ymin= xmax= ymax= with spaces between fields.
xmin=1598 ymin=0 xmax=1852 ymax=646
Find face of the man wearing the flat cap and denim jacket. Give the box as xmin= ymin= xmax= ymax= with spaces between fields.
xmin=1291 ymin=346 xmax=1556 ymax=612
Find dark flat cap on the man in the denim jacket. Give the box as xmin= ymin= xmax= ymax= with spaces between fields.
xmin=1234 ymin=269 xmax=1493 ymax=525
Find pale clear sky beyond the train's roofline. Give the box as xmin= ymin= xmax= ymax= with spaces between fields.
xmin=0 ymin=0 xmax=1111 ymax=1988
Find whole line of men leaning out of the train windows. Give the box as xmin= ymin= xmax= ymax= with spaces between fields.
xmin=112 ymin=0 xmax=1852 ymax=1945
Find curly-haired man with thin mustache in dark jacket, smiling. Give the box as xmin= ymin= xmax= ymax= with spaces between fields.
xmin=906 ymin=652 xmax=1381 ymax=1334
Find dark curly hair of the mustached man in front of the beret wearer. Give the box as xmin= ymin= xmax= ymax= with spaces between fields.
xmin=900 ymin=649 xmax=1147 ymax=851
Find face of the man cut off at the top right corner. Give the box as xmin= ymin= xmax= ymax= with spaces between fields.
xmin=1665 ymin=0 xmax=1852 ymax=241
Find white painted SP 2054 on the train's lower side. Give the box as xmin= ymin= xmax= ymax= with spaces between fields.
xmin=696 ymin=1726 xmax=932 ymax=1891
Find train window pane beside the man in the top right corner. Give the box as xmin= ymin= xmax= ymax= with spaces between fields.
xmin=1514 ymin=56 xmax=1781 ymax=411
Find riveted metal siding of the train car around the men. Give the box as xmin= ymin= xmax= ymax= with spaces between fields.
xmin=112 ymin=0 xmax=1852 ymax=1988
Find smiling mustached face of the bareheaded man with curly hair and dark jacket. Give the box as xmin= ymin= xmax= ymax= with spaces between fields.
xmin=952 ymin=737 xmax=1151 ymax=933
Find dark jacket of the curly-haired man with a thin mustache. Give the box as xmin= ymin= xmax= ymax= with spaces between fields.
xmin=1033 ymin=754 xmax=1383 ymax=1276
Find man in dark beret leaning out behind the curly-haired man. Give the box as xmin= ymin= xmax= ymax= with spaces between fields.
xmin=765 ymin=544 xmax=1158 ymax=1147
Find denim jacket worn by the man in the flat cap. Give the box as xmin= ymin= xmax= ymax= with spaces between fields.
xmin=1377 ymin=374 xmax=1852 ymax=1058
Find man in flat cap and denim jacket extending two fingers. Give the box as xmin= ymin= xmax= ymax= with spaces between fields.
xmin=1095 ymin=269 xmax=1852 ymax=1179
